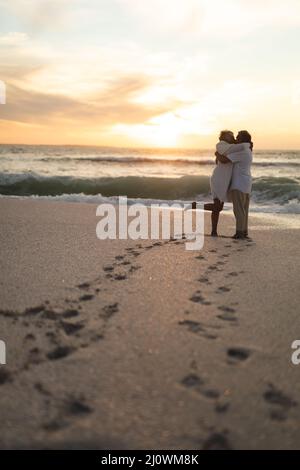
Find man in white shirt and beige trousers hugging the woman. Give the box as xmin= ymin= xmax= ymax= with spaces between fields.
xmin=216 ymin=131 xmax=253 ymax=239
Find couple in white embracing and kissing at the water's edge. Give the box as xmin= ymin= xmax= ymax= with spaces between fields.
xmin=204 ymin=130 xmax=253 ymax=239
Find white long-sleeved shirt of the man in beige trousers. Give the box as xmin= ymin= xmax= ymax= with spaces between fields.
xmin=224 ymin=143 xmax=252 ymax=194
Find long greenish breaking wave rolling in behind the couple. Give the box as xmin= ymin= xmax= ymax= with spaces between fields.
xmin=0 ymin=172 xmax=300 ymax=204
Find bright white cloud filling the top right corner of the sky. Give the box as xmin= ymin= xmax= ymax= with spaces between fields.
xmin=117 ymin=0 xmax=300 ymax=39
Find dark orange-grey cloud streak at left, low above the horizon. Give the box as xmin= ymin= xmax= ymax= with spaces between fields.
xmin=0 ymin=76 xmax=176 ymax=126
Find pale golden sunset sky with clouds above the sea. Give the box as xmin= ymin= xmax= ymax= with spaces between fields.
xmin=0 ymin=0 xmax=300 ymax=149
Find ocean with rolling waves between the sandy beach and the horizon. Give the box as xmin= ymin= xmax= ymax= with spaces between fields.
xmin=0 ymin=145 xmax=300 ymax=214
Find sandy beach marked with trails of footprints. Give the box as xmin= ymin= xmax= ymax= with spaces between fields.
xmin=0 ymin=198 xmax=300 ymax=449
